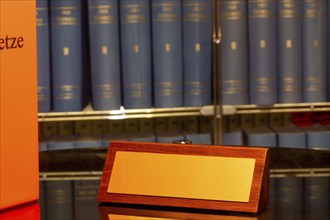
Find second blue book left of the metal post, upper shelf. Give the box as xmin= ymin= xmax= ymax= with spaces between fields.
xmin=151 ymin=0 xmax=183 ymax=108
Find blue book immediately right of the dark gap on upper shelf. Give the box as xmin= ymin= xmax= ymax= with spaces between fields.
xmin=88 ymin=0 xmax=121 ymax=110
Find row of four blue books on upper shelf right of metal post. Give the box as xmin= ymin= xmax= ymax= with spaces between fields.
xmin=218 ymin=0 xmax=330 ymax=105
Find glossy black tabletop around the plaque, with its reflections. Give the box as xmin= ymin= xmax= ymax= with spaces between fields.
xmin=34 ymin=146 xmax=330 ymax=220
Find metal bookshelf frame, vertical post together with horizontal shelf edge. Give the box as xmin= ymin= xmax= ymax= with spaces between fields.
xmin=38 ymin=0 xmax=330 ymax=148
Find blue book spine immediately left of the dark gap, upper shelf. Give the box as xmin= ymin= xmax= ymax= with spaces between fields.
xmin=50 ymin=0 xmax=83 ymax=111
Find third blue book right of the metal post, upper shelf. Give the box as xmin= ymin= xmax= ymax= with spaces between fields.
xmin=277 ymin=0 xmax=302 ymax=103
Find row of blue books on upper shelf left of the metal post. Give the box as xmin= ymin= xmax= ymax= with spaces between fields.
xmin=37 ymin=0 xmax=212 ymax=112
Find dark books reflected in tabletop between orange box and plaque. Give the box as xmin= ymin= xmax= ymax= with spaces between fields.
xmin=38 ymin=179 xmax=100 ymax=220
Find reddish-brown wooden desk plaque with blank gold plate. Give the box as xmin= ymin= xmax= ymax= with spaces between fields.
xmin=98 ymin=142 xmax=269 ymax=213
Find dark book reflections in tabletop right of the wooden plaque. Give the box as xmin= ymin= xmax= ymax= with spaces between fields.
xmin=269 ymin=176 xmax=330 ymax=220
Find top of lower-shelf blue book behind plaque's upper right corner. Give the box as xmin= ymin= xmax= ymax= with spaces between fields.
xmin=244 ymin=126 xmax=277 ymax=147
